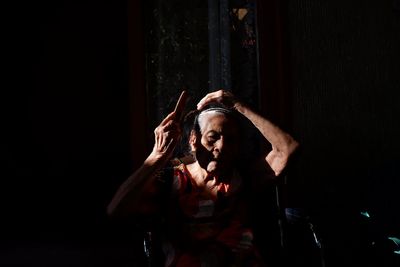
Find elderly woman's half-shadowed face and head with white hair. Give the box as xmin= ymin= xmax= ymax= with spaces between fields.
xmin=191 ymin=112 xmax=239 ymax=175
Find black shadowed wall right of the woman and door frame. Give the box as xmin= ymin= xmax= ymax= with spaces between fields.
xmin=285 ymin=0 xmax=400 ymax=266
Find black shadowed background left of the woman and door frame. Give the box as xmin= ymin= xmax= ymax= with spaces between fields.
xmin=0 ymin=1 xmax=139 ymax=266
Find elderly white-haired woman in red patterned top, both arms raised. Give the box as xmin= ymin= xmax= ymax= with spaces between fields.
xmin=108 ymin=90 xmax=298 ymax=266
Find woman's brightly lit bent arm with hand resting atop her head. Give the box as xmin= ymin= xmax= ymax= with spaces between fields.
xmin=197 ymin=90 xmax=299 ymax=176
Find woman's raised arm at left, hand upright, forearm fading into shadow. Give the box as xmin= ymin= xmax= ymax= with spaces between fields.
xmin=107 ymin=112 xmax=181 ymax=216
